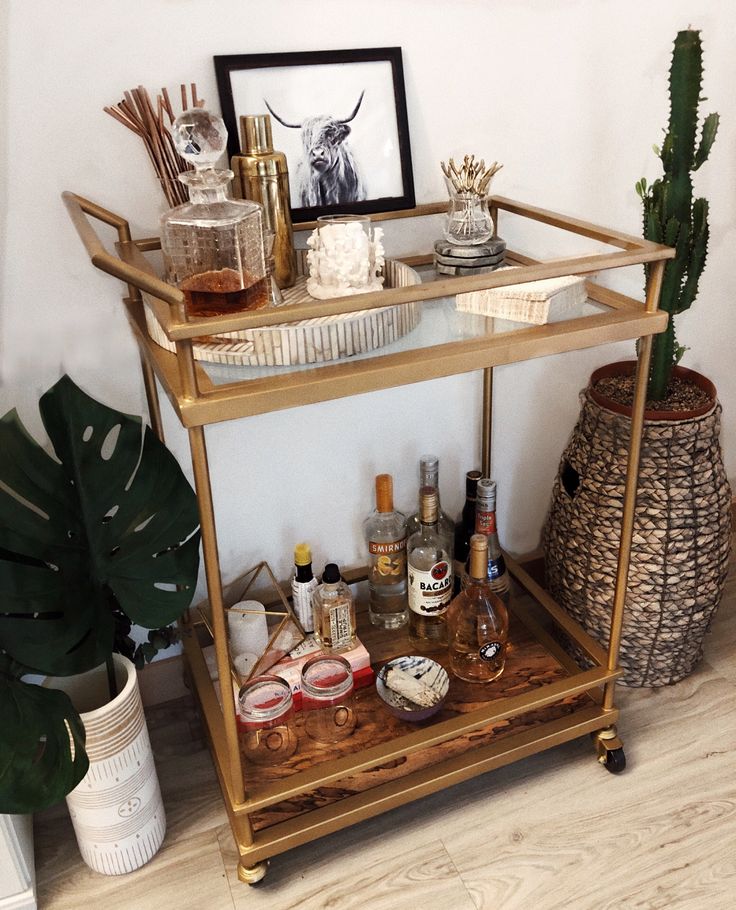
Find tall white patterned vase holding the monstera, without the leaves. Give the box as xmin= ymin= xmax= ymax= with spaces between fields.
xmin=54 ymin=654 xmax=166 ymax=875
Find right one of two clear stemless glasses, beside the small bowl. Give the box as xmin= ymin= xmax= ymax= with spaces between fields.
xmin=302 ymin=654 xmax=357 ymax=743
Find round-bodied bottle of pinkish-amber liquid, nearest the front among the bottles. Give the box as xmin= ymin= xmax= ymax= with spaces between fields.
xmin=447 ymin=534 xmax=509 ymax=682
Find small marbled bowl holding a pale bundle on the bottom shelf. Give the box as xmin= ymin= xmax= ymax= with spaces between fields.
xmin=376 ymin=655 xmax=450 ymax=723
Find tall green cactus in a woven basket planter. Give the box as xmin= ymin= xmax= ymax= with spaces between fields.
xmin=544 ymin=30 xmax=731 ymax=686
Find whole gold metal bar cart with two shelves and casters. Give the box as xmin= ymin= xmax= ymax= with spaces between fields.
xmin=64 ymin=193 xmax=674 ymax=883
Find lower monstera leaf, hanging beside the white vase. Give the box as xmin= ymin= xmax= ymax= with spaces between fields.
xmin=0 ymin=655 xmax=89 ymax=814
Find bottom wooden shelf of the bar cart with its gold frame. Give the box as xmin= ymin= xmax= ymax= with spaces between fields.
xmin=185 ymin=568 xmax=625 ymax=884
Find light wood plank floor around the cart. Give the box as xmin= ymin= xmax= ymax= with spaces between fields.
xmin=36 ymin=548 xmax=736 ymax=910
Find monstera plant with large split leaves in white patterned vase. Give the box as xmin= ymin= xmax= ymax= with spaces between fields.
xmin=0 ymin=376 xmax=199 ymax=874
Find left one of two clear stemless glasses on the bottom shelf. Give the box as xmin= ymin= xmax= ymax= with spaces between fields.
xmin=238 ymin=676 xmax=297 ymax=765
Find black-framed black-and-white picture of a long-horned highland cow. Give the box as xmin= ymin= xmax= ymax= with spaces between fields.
xmin=214 ymin=47 xmax=415 ymax=222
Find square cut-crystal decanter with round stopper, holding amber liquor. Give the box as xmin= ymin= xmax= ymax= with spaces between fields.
xmin=161 ymin=108 xmax=270 ymax=316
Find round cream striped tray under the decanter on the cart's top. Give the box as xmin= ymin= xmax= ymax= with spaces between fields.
xmin=145 ymin=250 xmax=422 ymax=366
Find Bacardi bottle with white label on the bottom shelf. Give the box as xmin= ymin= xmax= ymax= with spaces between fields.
xmin=406 ymin=487 xmax=452 ymax=652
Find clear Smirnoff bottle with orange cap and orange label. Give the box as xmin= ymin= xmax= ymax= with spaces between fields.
xmin=363 ymin=474 xmax=409 ymax=629
